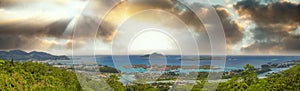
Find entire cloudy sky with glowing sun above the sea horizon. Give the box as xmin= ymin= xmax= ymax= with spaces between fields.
xmin=0 ymin=0 xmax=300 ymax=55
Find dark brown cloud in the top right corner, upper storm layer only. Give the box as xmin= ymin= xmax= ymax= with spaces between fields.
xmin=234 ymin=0 xmax=300 ymax=25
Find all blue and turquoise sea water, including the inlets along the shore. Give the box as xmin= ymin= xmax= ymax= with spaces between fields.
xmin=64 ymin=55 xmax=300 ymax=83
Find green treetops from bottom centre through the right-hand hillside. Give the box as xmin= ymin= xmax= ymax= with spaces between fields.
xmin=103 ymin=64 xmax=300 ymax=91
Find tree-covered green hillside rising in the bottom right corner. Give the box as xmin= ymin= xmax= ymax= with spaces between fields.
xmin=218 ymin=64 xmax=300 ymax=91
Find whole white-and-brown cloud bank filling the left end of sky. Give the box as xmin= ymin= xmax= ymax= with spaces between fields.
xmin=0 ymin=0 xmax=88 ymax=50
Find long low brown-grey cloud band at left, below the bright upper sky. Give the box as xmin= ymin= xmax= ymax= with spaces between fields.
xmin=0 ymin=19 xmax=71 ymax=37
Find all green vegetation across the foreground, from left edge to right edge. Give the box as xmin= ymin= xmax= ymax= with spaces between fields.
xmin=0 ymin=60 xmax=300 ymax=91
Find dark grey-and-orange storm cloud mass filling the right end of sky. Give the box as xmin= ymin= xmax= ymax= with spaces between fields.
xmin=234 ymin=0 xmax=300 ymax=51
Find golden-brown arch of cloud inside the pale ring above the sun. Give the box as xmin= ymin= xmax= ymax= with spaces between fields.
xmin=98 ymin=0 xmax=204 ymax=42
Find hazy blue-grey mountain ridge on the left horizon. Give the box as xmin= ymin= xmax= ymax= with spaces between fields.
xmin=0 ymin=50 xmax=70 ymax=61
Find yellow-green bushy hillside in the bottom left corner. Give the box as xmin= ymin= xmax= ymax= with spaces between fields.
xmin=0 ymin=60 xmax=81 ymax=91
